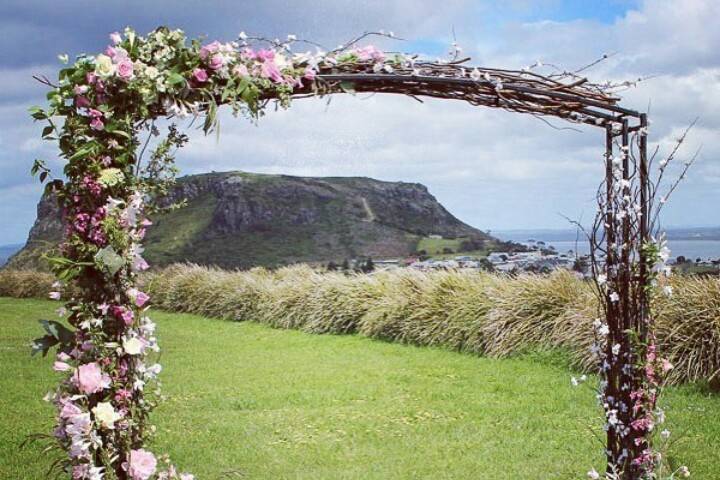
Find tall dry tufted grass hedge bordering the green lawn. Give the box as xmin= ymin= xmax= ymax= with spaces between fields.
xmin=0 ymin=265 xmax=720 ymax=383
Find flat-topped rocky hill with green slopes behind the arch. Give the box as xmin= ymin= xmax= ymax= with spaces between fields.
xmin=9 ymin=172 xmax=496 ymax=268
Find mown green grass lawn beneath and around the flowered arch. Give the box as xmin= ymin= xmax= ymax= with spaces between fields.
xmin=0 ymin=298 xmax=720 ymax=480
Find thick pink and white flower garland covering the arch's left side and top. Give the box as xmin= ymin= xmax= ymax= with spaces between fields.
xmin=31 ymin=28 xmax=410 ymax=480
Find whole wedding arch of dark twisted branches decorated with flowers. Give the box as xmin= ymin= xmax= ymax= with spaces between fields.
xmin=31 ymin=27 xmax=670 ymax=480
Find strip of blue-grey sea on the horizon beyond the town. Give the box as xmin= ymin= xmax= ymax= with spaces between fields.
xmin=490 ymin=227 xmax=720 ymax=261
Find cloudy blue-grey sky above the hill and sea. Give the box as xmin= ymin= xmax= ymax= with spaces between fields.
xmin=0 ymin=0 xmax=720 ymax=245
